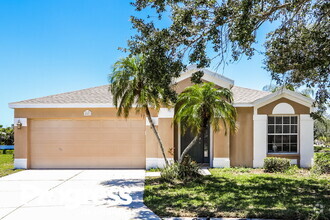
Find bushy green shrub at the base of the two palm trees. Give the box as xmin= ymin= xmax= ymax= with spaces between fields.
xmin=160 ymin=156 xmax=201 ymax=182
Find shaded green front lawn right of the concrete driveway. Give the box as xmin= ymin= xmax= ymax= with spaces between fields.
xmin=144 ymin=168 xmax=330 ymax=219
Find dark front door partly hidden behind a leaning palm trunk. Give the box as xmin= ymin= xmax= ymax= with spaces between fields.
xmin=181 ymin=128 xmax=210 ymax=163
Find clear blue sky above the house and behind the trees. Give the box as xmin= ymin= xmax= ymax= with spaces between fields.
xmin=0 ymin=0 xmax=271 ymax=126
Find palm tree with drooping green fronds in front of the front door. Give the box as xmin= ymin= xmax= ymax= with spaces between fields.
xmin=174 ymin=83 xmax=237 ymax=163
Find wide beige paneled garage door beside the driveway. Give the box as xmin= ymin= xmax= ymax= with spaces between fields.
xmin=30 ymin=119 xmax=145 ymax=168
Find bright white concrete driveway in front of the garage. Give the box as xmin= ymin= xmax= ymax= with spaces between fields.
xmin=0 ymin=169 xmax=159 ymax=220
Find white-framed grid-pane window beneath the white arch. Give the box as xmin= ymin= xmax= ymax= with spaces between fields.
xmin=268 ymin=116 xmax=298 ymax=153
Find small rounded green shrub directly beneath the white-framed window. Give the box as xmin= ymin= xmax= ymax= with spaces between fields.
xmin=264 ymin=157 xmax=290 ymax=173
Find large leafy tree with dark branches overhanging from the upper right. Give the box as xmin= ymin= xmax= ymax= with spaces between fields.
xmin=127 ymin=0 xmax=330 ymax=119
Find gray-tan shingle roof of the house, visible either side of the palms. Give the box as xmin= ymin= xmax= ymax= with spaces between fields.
xmin=10 ymin=85 xmax=270 ymax=105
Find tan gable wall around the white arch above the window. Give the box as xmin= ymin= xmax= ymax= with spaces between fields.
xmin=258 ymin=98 xmax=310 ymax=115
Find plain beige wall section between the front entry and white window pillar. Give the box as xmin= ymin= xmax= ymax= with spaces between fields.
xmin=230 ymin=107 xmax=253 ymax=167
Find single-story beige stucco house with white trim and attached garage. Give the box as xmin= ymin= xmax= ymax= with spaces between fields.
xmin=9 ymin=68 xmax=313 ymax=169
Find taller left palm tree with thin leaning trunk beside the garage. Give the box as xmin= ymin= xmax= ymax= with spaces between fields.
xmin=109 ymin=55 xmax=169 ymax=165
